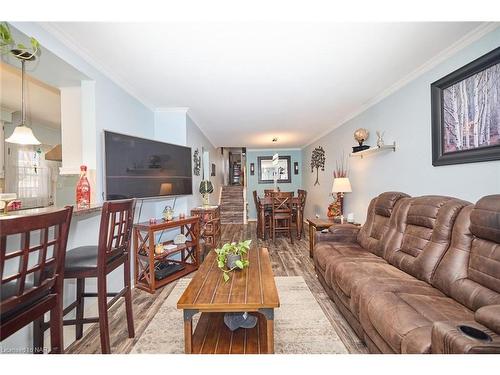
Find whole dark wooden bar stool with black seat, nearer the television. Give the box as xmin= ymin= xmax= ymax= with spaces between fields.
xmin=34 ymin=199 xmax=135 ymax=354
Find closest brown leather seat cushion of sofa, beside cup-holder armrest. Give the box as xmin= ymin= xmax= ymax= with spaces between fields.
xmin=360 ymin=292 xmax=474 ymax=353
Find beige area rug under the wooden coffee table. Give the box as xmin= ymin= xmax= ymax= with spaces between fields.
xmin=131 ymin=276 xmax=347 ymax=354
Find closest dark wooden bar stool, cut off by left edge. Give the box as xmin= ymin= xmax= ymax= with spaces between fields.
xmin=0 ymin=207 xmax=73 ymax=353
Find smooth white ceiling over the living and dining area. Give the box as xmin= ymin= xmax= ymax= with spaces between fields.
xmin=45 ymin=22 xmax=488 ymax=148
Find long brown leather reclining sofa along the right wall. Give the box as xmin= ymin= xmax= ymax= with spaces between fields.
xmin=314 ymin=192 xmax=500 ymax=353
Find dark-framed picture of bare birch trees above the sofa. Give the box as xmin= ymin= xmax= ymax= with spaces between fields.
xmin=431 ymin=47 xmax=500 ymax=166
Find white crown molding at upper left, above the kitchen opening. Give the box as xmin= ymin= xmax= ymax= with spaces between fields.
xmin=37 ymin=22 xmax=155 ymax=111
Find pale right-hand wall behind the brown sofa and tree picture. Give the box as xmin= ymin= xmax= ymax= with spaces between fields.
xmin=303 ymin=29 xmax=500 ymax=226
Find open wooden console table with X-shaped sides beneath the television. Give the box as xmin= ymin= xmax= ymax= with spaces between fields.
xmin=134 ymin=216 xmax=200 ymax=293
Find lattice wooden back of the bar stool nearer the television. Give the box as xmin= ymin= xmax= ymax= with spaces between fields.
xmin=97 ymin=199 xmax=135 ymax=271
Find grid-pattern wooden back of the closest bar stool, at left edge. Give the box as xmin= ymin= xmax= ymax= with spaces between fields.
xmin=0 ymin=207 xmax=73 ymax=328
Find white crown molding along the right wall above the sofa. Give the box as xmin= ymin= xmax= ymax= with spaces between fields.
xmin=302 ymin=22 xmax=500 ymax=149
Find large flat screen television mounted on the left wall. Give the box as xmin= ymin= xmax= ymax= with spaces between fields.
xmin=104 ymin=131 xmax=193 ymax=200
